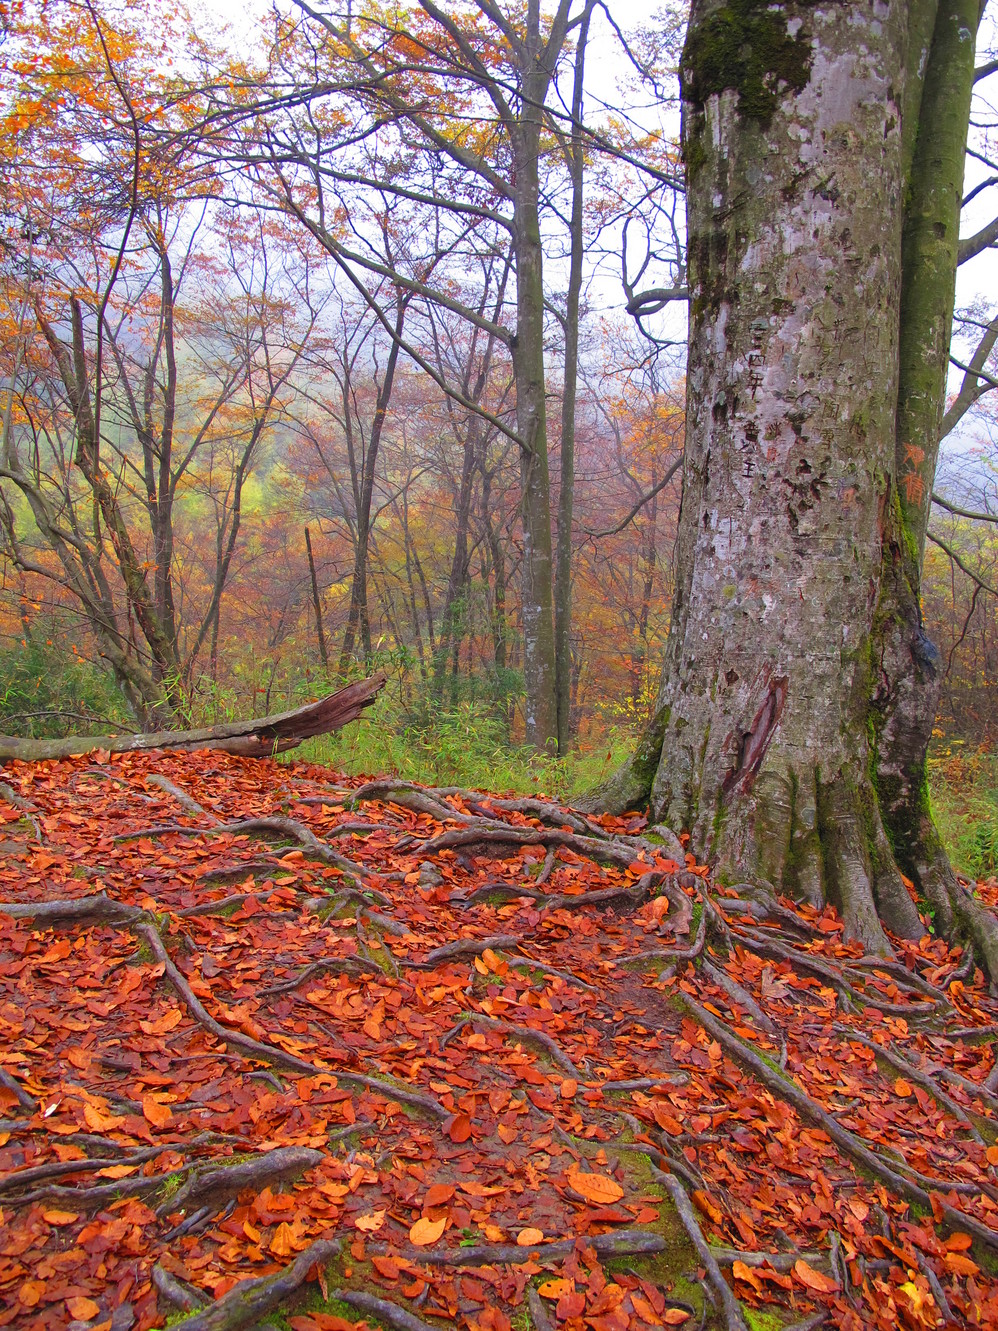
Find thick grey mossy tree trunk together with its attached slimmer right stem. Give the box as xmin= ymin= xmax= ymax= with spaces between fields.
xmin=601 ymin=0 xmax=998 ymax=976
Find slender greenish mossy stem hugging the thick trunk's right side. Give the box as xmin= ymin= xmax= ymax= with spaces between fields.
xmin=870 ymin=0 xmax=998 ymax=976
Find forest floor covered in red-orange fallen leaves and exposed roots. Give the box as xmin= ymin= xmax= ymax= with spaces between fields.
xmin=0 ymin=753 xmax=998 ymax=1331
